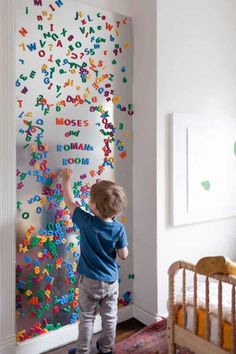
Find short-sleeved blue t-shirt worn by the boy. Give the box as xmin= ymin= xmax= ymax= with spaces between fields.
xmin=72 ymin=207 xmax=128 ymax=282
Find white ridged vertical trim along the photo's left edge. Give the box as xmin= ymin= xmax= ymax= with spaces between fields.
xmin=0 ymin=0 xmax=16 ymax=354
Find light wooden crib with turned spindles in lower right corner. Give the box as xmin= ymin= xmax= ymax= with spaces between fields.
xmin=167 ymin=261 xmax=236 ymax=354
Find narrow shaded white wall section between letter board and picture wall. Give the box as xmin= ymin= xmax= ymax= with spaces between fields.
xmin=132 ymin=0 xmax=158 ymax=324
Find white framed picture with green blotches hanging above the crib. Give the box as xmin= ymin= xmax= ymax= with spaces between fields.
xmin=170 ymin=113 xmax=236 ymax=226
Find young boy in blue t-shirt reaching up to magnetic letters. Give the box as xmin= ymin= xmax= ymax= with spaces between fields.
xmin=62 ymin=169 xmax=128 ymax=354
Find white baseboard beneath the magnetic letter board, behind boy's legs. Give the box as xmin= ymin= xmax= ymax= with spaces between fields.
xmin=16 ymin=305 xmax=133 ymax=354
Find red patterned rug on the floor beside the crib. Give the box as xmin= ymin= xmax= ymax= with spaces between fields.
xmin=113 ymin=319 xmax=194 ymax=354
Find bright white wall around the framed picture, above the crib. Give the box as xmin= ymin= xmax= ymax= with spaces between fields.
xmin=157 ymin=0 xmax=236 ymax=314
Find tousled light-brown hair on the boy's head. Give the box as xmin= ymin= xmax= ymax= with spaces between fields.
xmin=90 ymin=180 xmax=128 ymax=218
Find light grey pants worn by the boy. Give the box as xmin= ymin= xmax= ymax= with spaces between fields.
xmin=78 ymin=275 xmax=118 ymax=354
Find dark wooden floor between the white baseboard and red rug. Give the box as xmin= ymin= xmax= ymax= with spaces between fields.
xmin=44 ymin=318 xmax=145 ymax=354
